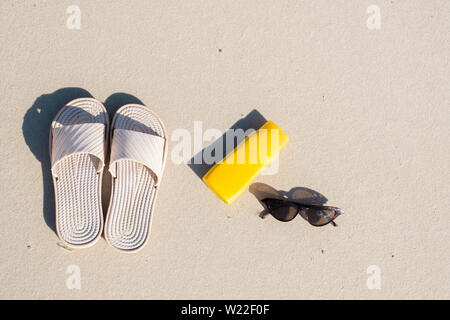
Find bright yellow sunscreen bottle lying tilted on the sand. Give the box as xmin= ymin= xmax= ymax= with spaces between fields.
xmin=203 ymin=121 xmax=289 ymax=204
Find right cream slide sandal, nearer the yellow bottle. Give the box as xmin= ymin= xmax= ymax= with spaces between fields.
xmin=105 ymin=104 xmax=167 ymax=252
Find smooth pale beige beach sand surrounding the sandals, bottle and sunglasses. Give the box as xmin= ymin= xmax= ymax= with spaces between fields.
xmin=0 ymin=0 xmax=450 ymax=299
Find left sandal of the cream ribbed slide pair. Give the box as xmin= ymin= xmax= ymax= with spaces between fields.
xmin=49 ymin=98 xmax=109 ymax=248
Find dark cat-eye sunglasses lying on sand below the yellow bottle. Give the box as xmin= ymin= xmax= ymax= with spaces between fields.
xmin=261 ymin=198 xmax=344 ymax=227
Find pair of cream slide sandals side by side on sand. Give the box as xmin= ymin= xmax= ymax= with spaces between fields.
xmin=50 ymin=98 xmax=167 ymax=252
